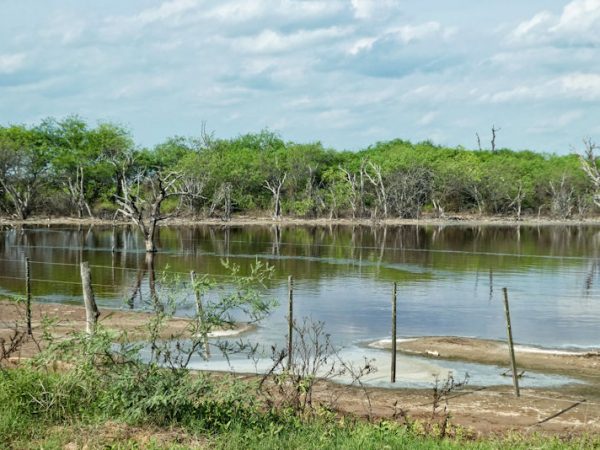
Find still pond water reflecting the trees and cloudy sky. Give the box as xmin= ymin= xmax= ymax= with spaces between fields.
xmin=0 ymin=226 xmax=600 ymax=386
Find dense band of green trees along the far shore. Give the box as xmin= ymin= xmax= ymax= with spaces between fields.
xmin=0 ymin=117 xmax=594 ymax=219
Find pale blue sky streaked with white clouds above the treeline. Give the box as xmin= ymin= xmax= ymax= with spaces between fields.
xmin=0 ymin=0 xmax=600 ymax=154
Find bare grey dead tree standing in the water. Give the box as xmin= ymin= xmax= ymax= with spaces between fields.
xmin=115 ymin=171 xmax=186 ymax=252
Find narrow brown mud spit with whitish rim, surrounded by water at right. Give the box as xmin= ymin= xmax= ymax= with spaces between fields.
xmin=370 ymin=336 xmax=600 ymax=383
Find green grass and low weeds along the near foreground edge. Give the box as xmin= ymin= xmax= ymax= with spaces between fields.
xmin=0 ymin=367 xmax=600 ymax=450
